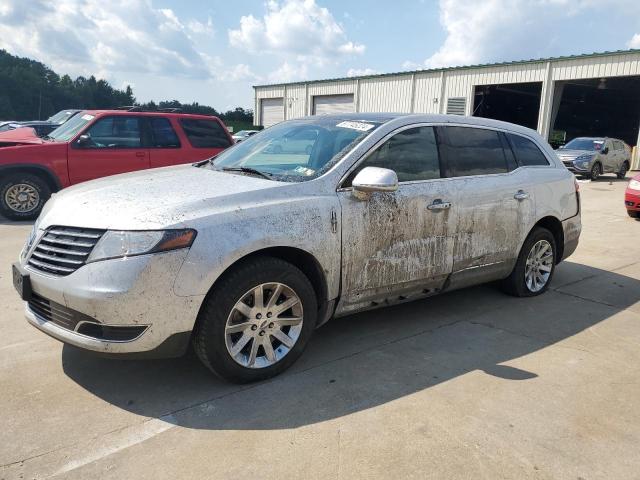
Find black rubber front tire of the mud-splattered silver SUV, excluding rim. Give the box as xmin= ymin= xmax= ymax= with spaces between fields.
xmin=193 ymin=257 xmax=318 ymax=383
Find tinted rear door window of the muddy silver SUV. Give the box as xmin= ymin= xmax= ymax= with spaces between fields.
xmin=439 ymin=127 xmax=507 ymax=177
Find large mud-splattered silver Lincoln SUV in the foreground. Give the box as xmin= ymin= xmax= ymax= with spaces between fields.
xmin=13 ymin=114 xmax=581 ymax=382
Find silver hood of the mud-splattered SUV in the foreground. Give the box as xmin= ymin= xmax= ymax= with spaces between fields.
xmin=39 ymin=165 xmax=292 ymax=230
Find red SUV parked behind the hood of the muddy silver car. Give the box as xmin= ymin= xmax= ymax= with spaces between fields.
xmin=0 ymin=110 xmax=233 ymax=220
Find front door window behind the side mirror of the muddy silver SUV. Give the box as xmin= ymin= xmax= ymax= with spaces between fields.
xmin=344 ymin=127 xmax=440 ymax=187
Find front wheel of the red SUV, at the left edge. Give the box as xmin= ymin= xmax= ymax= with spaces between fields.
xmin=0 ymin=173 xmax=51 ymax=220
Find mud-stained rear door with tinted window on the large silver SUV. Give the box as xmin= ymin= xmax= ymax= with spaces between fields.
xmin=438 ymin=126 xmax=535 ymax=287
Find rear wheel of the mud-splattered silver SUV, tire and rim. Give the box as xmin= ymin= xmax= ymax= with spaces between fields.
xmin=502 ymin=227 xmax=556 ymax=297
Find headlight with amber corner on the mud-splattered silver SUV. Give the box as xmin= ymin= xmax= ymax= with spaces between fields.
xmin=87 ymin=229 xmax=196 ymax=263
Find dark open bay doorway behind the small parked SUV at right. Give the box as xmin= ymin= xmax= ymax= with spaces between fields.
xmin=549 ymin=76 xmax=640 ymax=145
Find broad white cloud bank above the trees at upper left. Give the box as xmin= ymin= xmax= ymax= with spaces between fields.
xmin=0 ymin=0 xmax=212 ymax=78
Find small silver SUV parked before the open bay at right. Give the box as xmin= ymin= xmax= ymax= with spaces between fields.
xmin=556 ymin=137 xmax=631 ymax=180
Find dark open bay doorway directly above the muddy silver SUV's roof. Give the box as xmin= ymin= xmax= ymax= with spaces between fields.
xmin=473 ymin=82 xmax=542 ymax=130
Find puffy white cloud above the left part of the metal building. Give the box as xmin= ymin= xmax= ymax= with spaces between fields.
xmin=229 ymin=0 xmax=365 ymax=64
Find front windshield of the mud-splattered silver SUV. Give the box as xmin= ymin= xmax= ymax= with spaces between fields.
xmin=213 ymin=117 xmax=380 ymax=182
